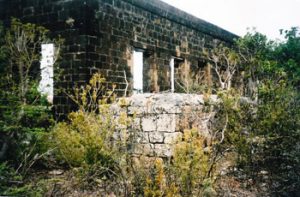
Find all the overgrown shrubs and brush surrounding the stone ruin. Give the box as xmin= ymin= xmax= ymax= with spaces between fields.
xmin=0 ymin=19 xmax=300 ymax=196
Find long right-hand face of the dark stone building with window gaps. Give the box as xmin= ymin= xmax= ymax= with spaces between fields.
xmin=89 ymin=0 xmax=236 ymax=92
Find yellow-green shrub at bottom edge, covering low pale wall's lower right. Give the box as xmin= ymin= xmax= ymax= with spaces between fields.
xmin=143 ymin=130 xmax=216 ymax=196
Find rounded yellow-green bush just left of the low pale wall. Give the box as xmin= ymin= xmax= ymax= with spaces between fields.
xmin=53 ymin=109 xmax=115 ymax=166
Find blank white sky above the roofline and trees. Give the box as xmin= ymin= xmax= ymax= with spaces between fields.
xmin=162 ymin=0 xmax=300 ymax=40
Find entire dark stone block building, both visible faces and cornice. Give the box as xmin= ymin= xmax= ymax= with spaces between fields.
xmin=0 ymin=0 xmax=237 ymax=114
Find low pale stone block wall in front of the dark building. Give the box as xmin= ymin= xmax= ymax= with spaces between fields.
xmin=114 ymin=93 xmax=216 ymax=157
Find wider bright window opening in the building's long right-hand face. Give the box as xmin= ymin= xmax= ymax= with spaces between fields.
xmin=133 ymin=49 xmax=144 ymax=94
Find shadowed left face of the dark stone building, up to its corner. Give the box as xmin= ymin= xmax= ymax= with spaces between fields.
xmin=0 ymin=0 xmax=96 ymax=116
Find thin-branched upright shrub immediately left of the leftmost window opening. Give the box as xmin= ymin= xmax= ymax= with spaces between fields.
xmin=4 ymin=18 xmax=49 ymax=104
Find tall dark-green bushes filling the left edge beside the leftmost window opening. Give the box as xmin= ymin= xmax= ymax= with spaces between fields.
xmin=0 ymin=19 xmax=59 ymax=168
